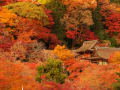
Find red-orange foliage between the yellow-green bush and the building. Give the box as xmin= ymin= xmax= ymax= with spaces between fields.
xmin=64 ymin=59 xmax=94 ymax=80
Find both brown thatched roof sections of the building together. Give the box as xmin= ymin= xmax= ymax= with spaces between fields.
xmin=73 ymin=40 xmax=120 ymax=60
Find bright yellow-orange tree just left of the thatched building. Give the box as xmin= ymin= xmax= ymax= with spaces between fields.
xmin=53 ymin=45 xmax=74 ymax=60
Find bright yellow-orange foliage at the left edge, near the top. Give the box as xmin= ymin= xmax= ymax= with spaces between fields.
xmin=0 ymin=8 xmax=17 ymax=26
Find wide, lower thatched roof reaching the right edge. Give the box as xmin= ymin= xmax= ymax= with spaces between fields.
xmin=95 ymin=47 xmax=120 ymax=59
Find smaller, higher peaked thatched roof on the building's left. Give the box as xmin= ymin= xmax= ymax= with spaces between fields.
xmin=73 ymin=40 xmax=98 ymax=53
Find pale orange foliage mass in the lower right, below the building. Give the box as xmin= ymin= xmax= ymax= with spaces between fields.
xmin=73 ymin=64 xmax=120 ymax=90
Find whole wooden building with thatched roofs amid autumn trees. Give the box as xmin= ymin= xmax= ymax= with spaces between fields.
xmin=73 ymin=40 xmax=120 ymax=64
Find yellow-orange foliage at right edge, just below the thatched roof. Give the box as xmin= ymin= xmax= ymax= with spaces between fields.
xmin=108 ymin=51 xmax=120 ymax=64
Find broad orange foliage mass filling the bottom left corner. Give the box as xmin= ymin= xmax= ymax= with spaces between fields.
xmin=0 ymin=59 xmax=38 ymax=90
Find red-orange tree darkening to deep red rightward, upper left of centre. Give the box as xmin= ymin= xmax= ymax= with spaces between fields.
xmin=14 ymin=18 xmax=60 ymax=48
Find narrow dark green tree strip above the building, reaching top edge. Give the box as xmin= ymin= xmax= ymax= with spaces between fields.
xmin=91 ymin=0 xmax=105 ymax=40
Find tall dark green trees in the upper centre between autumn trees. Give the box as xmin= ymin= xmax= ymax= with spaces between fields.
xmin=46 ymin=0 xmax=66 ymax=41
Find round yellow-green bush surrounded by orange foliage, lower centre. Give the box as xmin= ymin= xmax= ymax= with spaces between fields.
xmin=36 ymin=59 xmax=67 ymax=83
